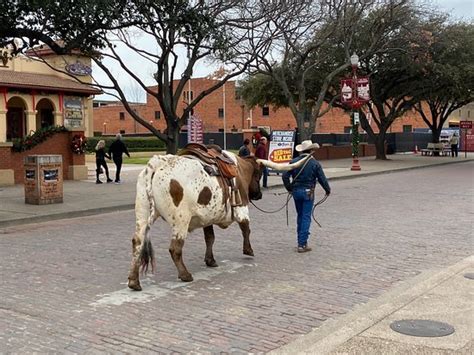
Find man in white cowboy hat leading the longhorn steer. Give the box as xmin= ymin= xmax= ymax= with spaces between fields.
xmin=282 ymin=140 xmax=331 ymax=253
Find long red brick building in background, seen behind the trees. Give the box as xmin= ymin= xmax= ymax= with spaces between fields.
xmin=94 ymin=78 xmax=426 ymax=134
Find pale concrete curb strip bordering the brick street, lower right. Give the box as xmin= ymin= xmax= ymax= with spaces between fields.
xmin=269 ymin=255 xmax=474 ymax=355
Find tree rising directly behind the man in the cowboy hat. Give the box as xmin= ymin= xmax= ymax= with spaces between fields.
xmin=241 ymin=0 xmax=410 ymax=144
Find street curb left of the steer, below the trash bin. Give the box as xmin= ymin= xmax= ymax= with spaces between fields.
xmin=0 ymin=204 xmax=135 ymax=228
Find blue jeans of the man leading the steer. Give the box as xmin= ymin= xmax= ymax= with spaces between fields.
xmin=292 ymin=188 xmax=314 ymax=247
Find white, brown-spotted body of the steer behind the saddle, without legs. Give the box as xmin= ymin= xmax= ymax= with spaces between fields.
xmin=135 ymin=155 xmax=231 ymax=230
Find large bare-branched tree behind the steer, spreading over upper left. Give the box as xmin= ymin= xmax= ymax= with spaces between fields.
xmin=0 ymin=0 xmax=274 ymax=153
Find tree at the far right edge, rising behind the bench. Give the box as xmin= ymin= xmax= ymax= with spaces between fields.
xmin=415 ymin=23 xmax=474 ymax=143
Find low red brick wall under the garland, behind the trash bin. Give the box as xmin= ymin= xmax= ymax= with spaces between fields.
xmin=0 ymin=131 xmax=85 ymax=184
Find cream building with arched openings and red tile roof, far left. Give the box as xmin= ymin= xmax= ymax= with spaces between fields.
xmin=0 ymin=47 xmax=100 ymax=184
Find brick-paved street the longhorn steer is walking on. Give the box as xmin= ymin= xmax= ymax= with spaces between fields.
xmin=0 ymin=162 xmax=474 ymax=354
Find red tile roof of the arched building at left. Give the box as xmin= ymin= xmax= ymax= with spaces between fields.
xmin=0 ymin=70 xmax=102 ymax=95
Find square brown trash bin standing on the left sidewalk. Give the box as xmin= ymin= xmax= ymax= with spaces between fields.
xmin=24 ymin=155 xmax=63 ymax=205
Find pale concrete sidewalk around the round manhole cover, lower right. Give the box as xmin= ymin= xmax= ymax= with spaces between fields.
xmin=270 ymin=256 xmax=474 ymax=355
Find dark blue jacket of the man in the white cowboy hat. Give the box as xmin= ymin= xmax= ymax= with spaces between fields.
xmin=282 ymin=153 xmax=331 ymax=194
